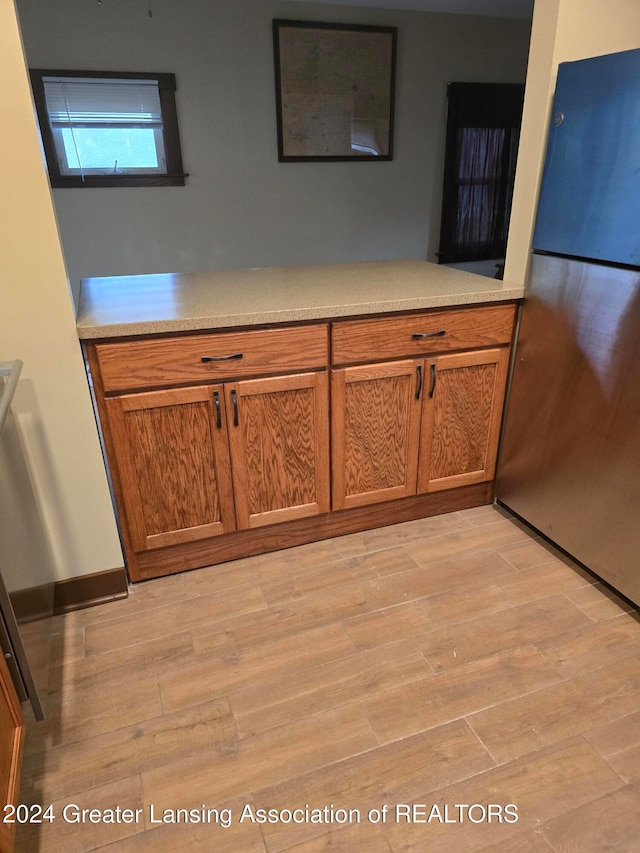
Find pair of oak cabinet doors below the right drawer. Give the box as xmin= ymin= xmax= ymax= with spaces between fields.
xmin=331 ymin=349 xmax=509 ymax=509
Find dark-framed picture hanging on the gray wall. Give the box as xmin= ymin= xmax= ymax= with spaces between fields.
xmin=273 ymin=19 xmax=397 ymax=162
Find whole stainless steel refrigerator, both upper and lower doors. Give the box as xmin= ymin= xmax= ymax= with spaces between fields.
xmin=496 ymin=49 xmax=640 ymax=604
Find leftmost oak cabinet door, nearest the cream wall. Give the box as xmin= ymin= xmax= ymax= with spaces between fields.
xmin=107 ymin=386 xmax=235 ymax=551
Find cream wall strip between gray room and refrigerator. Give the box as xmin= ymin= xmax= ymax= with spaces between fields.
xmin=504 ymin=0 xmax=640 ymax=282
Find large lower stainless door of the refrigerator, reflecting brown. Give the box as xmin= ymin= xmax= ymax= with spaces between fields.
xmin=496 ymin=255 xmax=640 ymax=604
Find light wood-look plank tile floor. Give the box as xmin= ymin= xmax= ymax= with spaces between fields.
xmin=16 ymin=507 xmax=640 ymax=853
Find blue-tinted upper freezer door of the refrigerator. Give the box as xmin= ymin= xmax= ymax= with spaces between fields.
xmin=533 ymin=49 xmax=640 ymax=266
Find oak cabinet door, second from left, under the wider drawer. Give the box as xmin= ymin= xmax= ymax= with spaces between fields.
xmin=225 ymin=373 xmax=329 ymax=528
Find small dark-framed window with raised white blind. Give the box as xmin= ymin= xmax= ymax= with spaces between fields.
xmin=30 ymin=69 xmax=186 ymax=187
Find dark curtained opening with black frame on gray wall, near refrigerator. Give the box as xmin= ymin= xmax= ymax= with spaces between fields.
xmin=438 ymin=83 xmax=524 ymax=263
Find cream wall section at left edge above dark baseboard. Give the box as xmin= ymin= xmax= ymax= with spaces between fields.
xmin=0 ymin=0 xmax=123 ymax=578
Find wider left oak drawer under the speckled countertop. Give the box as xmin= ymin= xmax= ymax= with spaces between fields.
xmin=95 ymin=323 xmax=329 ymax=391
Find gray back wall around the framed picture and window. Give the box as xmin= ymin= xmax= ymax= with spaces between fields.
xmin=17 ymin=0 xmax=529 ymax=302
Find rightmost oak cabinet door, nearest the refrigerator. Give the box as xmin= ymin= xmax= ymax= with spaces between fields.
xmin=418 ymin=349 xmax=509 ymax=492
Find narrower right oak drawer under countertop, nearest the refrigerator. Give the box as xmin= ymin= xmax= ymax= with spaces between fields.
xmin=332 ymin=304 xmax=516 ymax=364
